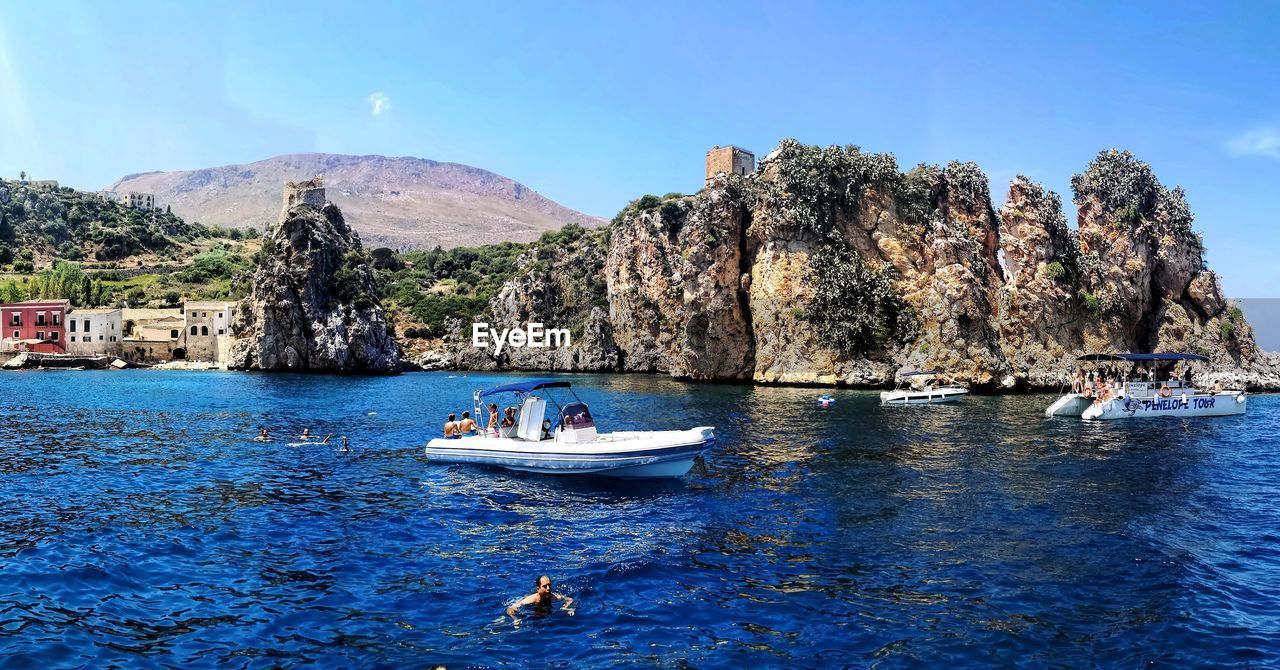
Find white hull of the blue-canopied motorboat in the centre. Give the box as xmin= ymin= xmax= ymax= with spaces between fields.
xmin=426 ymin=428 xmax=716 ymax=478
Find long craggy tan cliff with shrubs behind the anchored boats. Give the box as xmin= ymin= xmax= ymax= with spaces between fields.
xmin=422 ymin=141 xmax=1280 ymax=389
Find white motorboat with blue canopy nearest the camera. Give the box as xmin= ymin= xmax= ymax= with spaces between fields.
xmin=426 ymin=379 xmax=716 ymax=478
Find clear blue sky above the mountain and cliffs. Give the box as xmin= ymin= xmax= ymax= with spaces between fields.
xmin=0 ymin=1 xmax=1280 ymax=297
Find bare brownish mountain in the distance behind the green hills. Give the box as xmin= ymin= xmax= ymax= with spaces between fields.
xmin=108 ymin=154 xmax=604 ymax=249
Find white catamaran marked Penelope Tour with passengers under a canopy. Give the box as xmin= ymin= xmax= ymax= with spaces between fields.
xmin=1044 ymin=354 xmax=1248 ymax=420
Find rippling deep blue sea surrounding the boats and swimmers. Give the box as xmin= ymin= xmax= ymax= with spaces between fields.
xmin=0 ymin=370 xmax=1280 ymax=669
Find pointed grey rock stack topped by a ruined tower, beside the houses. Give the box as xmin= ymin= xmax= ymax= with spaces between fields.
xmin=229 ymin=178 xmax=401 ymax=374
